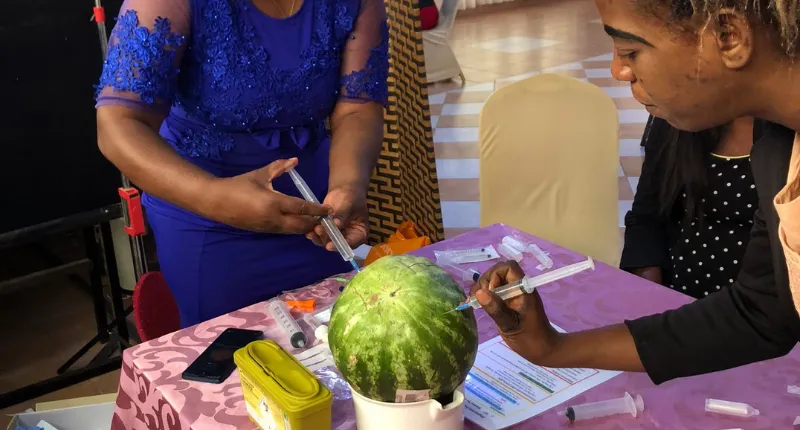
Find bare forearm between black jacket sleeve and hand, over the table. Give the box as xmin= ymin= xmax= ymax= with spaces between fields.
xmin=535 ymin=324 xmax=644 ymax=372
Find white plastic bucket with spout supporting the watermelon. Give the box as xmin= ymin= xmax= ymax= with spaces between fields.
xmin=350 ymin=384 xmax=464 ymax=430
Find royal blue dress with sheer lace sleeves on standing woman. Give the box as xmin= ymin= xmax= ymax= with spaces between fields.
xmin=97 ymin=0 xmax=388 ymax=327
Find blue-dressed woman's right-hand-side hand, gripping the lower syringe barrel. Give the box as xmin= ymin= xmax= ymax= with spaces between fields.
xmin=306 ymin=186 xmax=369 ymax=251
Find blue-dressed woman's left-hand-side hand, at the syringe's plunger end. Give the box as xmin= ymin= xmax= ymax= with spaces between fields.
xmin=205 ymin=158 xmax=333 ymax=234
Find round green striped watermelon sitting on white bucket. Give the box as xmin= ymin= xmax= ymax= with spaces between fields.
xmin=328 ymin=255 xmax=478 ymax=402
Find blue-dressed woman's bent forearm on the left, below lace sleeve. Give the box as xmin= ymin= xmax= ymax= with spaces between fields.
xmin=97 ymin=106 xmax=215 ymax=216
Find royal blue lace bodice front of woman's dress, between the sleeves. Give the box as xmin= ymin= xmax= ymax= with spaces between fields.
xmin=176 ymin=0 xmax=358 ymax=132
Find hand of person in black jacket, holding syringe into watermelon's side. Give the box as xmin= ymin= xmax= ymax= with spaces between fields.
xmin=470 ymin=261 xmax=561 ymax=365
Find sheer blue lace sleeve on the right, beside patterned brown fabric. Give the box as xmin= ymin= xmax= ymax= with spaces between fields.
xmin=340 ymin=0 xmax=389 ymax=104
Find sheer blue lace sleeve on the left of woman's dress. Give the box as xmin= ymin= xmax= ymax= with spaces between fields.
xmin=96 ymin=0 xmax=189 ymax=113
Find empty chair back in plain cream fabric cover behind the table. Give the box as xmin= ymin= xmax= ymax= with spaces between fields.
xmin=478 ymin=74 xmax=620 ymax=266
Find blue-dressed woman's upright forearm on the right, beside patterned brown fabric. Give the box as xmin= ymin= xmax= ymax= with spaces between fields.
xmin=329 ymin=103 xmax=383 ymax=190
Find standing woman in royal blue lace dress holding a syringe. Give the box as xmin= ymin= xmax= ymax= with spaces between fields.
xmin=97 ymin=0 xmax=388 ymax=327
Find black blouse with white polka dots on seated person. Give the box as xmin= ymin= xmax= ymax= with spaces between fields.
xmin=670 ymin=155 xmax=758 ymax=298
